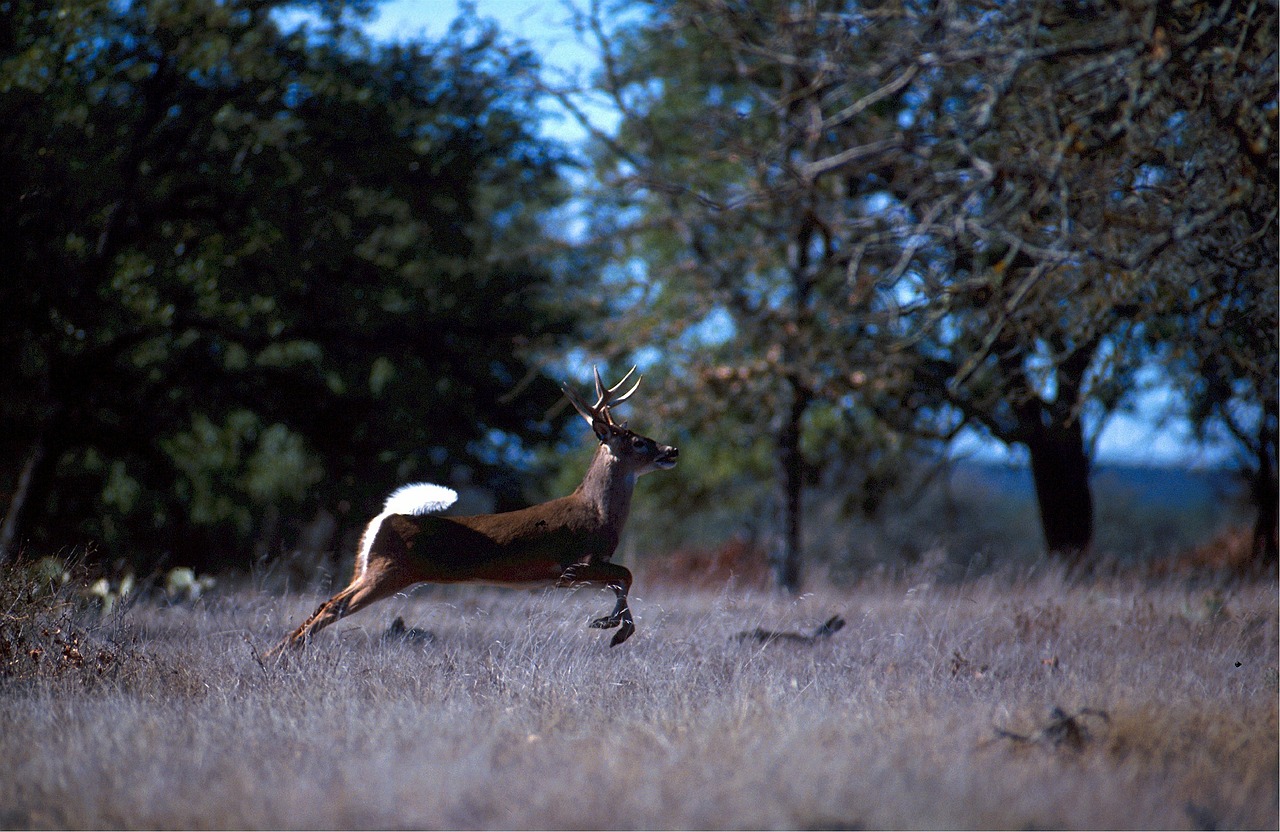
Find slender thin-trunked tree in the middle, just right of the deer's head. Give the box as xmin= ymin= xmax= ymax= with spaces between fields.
xmin=560 ymin=1 xmax=931 ymax=590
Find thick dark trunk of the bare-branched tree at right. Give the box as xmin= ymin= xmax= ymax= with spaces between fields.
xmin=1027 ymin=419 xmax=1093 ymax=566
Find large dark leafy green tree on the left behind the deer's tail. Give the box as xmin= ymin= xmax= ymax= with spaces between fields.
xmin=0 ymin=0 xmax=573 ymax=566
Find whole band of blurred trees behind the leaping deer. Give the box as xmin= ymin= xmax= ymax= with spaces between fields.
xmin=0 ymin=0 xmax=1280 ymax=589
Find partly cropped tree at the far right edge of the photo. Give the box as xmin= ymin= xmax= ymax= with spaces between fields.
xmin=1146 ymin=4 xmax=1280 ymax=564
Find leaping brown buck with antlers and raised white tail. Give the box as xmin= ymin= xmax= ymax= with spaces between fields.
xmin=268 ymin=367 xmax=680 ymax=657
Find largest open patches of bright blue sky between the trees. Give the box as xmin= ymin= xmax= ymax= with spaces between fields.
xmin=345 ymin=0 xmax=1230 ymax=467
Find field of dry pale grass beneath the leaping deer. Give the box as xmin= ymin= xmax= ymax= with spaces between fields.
xmin=0 ymin=560 xmax=1280 ymax=829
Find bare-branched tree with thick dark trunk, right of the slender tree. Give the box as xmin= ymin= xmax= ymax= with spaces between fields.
xmin=890 ymin=3 xmax=1276 ymax=561
